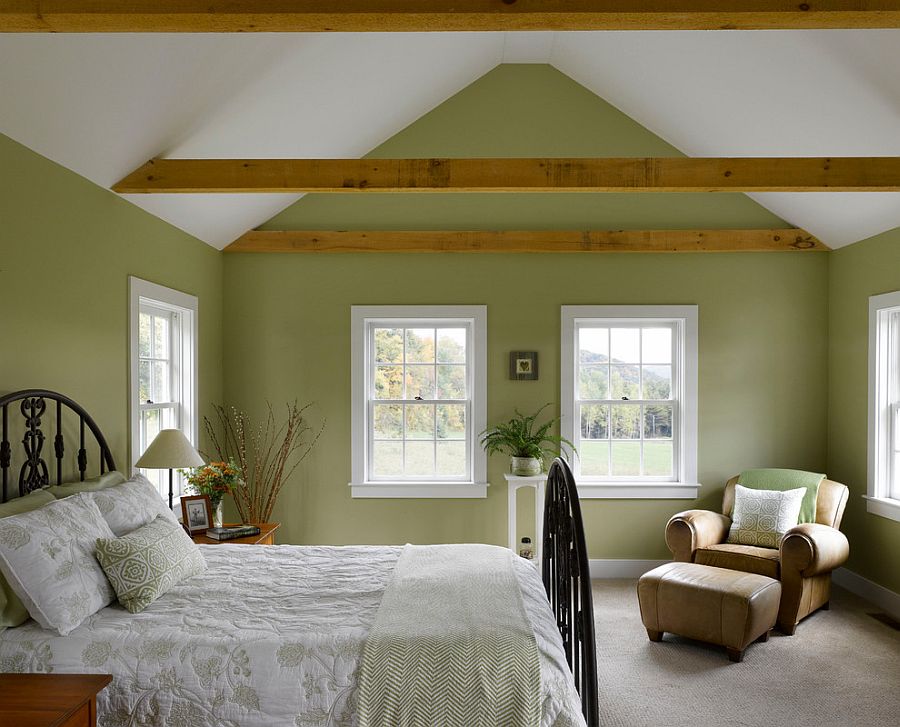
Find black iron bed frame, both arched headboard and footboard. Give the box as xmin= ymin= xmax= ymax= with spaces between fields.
xmin=0 ymin=389 xmax=599 ymax=727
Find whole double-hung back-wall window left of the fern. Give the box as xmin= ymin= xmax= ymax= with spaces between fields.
xmin=351 ymin=306 xmax=487 ymax=497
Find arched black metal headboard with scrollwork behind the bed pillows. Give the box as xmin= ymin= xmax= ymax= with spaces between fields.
xmin=0 ymin=389 xmax=116 ymax=502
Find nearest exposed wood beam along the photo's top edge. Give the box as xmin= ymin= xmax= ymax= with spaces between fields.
xmin=0 ymin=0 xmax=900 ymax=33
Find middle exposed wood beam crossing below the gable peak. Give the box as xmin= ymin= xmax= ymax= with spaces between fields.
xmin=113 ymin=157 xmax=900 ymax=194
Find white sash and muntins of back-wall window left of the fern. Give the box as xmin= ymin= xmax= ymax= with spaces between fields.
xmin=365 ymin=318 xmax=475 ymax=483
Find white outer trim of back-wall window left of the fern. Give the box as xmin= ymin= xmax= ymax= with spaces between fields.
xmin=350 ymin=305 xmax=488 ymax=498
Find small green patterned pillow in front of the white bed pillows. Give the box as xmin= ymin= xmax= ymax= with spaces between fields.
xmin=97 ymin=515 xmax=206 ymax=613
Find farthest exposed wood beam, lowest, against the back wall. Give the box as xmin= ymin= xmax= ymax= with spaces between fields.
xmin=225 ymin=229 xmax=829 ymax=253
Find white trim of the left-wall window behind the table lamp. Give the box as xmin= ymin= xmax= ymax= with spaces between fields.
xmin=128 ymin=275 xmax=200 ymax=507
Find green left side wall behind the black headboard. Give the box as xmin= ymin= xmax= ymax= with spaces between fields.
xmin=0 ymin=135 xmax=223 ymax=470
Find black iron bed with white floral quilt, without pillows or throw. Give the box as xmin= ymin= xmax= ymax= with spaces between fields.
xmin=0 ymin=390 xmax=598 ymax=727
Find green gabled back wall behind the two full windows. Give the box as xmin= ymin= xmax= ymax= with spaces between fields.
xmin=225 ymin=65 xmax=828 ymax=558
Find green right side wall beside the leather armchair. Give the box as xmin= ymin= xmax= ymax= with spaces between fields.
xmin=828 ymin=229 xmax=900 ymax=593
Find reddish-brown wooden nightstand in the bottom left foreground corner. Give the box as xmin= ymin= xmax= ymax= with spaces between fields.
xmin=0 ymin=674 xmax=112 ymax=727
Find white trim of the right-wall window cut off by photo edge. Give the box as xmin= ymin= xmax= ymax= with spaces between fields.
xmin=865 ymin=291 xmax=900 ymax=522
